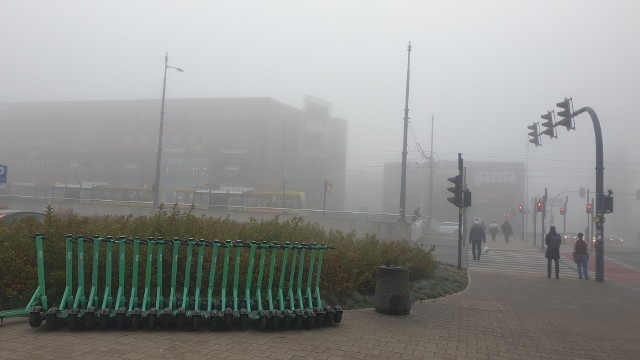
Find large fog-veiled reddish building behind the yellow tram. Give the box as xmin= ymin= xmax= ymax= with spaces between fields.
xmin=0 ymin=97 xmax=347 ymax=210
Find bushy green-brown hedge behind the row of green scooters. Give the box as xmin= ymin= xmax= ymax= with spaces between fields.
xmin=0 ymin=206 xmax=437 ymax=310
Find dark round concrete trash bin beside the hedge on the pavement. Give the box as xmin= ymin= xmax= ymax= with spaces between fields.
xmin=375 ymin=265 xmax=411 ymax=315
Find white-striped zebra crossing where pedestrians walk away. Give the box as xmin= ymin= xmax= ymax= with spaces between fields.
xmin=468 ymin=248 xmax=576 ymax=277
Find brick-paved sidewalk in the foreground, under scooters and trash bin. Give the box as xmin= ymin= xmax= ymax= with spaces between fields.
xmin=0 ymin=272 xmax=640 ymax=360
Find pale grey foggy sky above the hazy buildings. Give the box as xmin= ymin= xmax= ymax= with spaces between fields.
xmin=0 ymin=0 xmax=640 ymax=221
